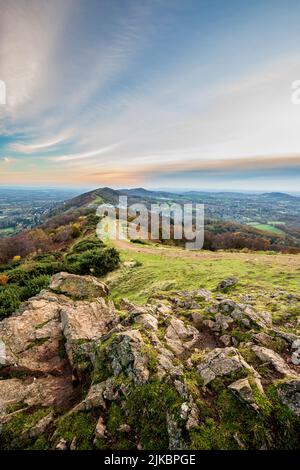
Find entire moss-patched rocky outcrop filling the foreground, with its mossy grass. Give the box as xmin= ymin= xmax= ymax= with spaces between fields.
xmin=0 ymin=273 xmax=300 ymax=450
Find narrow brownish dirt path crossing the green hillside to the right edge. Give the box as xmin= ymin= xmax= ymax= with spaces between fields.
xmin=114 ymin=240 xmax=300 ymax=269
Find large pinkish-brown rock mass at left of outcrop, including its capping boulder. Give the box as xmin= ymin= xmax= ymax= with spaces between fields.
xmin=0 ymin=273 xmax=117 ymax=418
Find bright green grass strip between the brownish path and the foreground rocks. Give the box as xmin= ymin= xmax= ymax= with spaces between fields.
xmin=106 ymin=249 xmax=300 ymax=304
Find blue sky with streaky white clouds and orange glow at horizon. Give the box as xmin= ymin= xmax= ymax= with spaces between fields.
xmin=0 ymin=0 xmax=300 ymax=192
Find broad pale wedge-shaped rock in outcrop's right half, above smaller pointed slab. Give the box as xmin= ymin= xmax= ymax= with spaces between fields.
xmin=197 ymin=347 xmax=257 ymax=385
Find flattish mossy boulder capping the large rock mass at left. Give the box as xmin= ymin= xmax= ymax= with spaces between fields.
xmin=50 ymin=272 xmax=108 ymax=299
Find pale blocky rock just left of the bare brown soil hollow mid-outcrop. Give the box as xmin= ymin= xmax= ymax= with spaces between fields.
xmin=165 ymin=318 xmax=200 ymax=356
